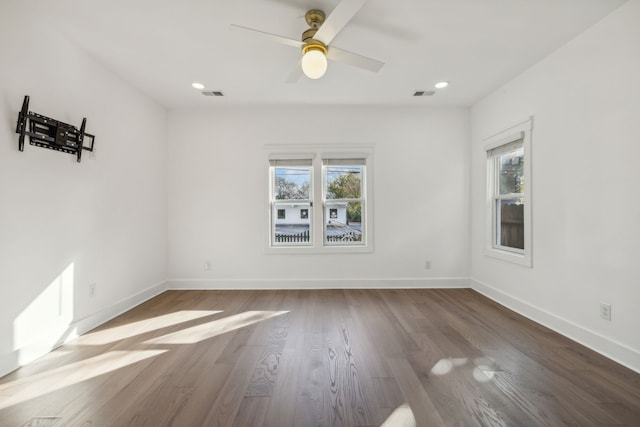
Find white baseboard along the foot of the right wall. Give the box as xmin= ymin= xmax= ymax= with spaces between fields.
xmin=469 ymin=279 xmax=640 ymax=373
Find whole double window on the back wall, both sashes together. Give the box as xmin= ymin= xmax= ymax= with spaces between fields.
xmin=268 ymin=146 xmax=372 ymax=253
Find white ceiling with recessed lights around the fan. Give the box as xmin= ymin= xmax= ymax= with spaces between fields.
xmin=19 ymin=0 xmax=625 ymax=108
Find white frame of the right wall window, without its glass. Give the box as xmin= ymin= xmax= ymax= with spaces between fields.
xmin=484 ymin=116 xmax=533 ymax=267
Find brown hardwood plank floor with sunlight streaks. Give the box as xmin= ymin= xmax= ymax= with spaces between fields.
xmin=0 ymin=289 xmax=640 ymax=427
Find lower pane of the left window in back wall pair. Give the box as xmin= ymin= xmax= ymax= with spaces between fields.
xmin=273 ymin=202 xmax=311 ymax=244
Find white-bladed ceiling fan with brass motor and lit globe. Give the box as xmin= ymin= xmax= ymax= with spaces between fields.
xmin=231 ymin=0 xmax=384 ymax=83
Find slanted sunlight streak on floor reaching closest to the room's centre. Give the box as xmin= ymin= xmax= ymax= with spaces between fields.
xmin=144 ymin=311 xmax=288 ymax=344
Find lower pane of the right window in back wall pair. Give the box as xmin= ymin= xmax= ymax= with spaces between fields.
xmin=325 ymin=202 xmax=364 ymax=244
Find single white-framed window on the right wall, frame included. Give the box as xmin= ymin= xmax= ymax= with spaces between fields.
xmin=485 ymin=118 xmax=532 ymax=266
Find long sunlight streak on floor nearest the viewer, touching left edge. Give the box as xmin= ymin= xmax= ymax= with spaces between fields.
xmin=0 ymin=350 xmax=168 ymax=409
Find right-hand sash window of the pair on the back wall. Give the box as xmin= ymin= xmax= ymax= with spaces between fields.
xmin=322 ymin=159 xmax=366 ymax=246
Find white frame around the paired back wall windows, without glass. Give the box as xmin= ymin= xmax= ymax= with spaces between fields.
xmin=264 ymin=144 xmax=374 ymax=254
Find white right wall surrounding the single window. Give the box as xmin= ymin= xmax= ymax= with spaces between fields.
xmin=471 ymin=1 xmax=640 ymax=370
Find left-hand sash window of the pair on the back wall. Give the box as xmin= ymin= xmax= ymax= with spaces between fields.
xmin=270 ymin=159 xmax=313 ymax=246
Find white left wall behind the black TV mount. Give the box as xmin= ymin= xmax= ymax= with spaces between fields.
xmin=0 ymin=2 xmax=167 ymax=375
